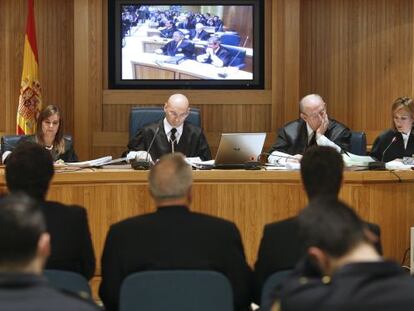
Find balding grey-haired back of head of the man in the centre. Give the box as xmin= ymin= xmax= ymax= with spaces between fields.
xmin=148 ymin=153 xmax=193 ymax=202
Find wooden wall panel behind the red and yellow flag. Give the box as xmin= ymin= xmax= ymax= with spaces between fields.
xmin=0 ymin=0 xmax=74 ymax=133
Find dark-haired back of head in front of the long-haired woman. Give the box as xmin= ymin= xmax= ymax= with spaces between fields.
xmin=6 ymin=142 xmax=54 ymax=200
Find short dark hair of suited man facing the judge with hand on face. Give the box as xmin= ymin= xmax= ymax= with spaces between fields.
xmin=300 ymin=146 xmax=344 ymax=199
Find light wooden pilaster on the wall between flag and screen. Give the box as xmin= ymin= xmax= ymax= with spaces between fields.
xmin=73 ymin=0 xmax=103 ymax=159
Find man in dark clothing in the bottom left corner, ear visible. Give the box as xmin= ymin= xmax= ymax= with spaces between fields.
xmin=0 ymin=194 xmax=99 ymax=311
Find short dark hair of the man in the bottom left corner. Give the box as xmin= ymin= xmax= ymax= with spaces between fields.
xmin=0 ymin=193 xmax=46 ymax=266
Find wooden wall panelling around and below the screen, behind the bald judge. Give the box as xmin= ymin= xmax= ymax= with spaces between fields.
xmin=92 ymin=0 xmax=300 ymax=157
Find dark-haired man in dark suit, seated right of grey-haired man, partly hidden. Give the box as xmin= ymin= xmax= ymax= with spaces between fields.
xmin=255 ymin=146 xmax=382 ymax=302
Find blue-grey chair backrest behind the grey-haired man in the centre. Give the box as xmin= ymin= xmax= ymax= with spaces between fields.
xmin=119 ymin=270 xmax=233 ymax=311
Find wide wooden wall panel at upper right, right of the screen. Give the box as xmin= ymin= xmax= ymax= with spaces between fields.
xmin=300 ymin=0 xmax=414 ymax=131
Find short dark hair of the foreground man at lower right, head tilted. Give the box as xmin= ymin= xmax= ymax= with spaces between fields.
xmin=298 ymin=197 xmax=367 ymax=258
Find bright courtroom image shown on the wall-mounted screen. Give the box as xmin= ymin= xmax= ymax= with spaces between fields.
xmin=120 ymin=5 xmax=254 ymax=80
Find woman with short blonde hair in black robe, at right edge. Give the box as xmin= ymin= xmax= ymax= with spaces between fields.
xmin=371 ymin=97 xmax=414 ymax=162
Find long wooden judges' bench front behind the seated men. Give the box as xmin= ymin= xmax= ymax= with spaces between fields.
xmin=0 ymin=169 xmax=414 ymax=294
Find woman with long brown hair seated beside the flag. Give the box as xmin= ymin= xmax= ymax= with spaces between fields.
xmin=18 ymin=105 xmax=78 ymax=162
